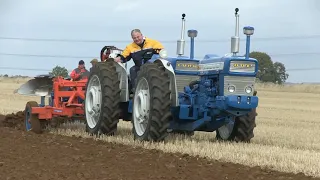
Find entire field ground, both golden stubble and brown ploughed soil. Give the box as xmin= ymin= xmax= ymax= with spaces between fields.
xmin=0 ymin=79 xmax=320 ymax=180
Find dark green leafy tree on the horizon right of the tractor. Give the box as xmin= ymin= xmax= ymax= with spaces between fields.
xmin=249 ymin=51 xmax=289 ymax=84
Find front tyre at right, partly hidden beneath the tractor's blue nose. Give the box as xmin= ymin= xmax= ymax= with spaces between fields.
xmin=216 ymin=91 xmax=258 ymax=143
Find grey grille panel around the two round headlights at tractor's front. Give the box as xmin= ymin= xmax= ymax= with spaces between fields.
xmin=224 ymin=76 xmax=256 ymax=96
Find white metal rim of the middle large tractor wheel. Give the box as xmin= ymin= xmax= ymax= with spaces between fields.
xmin=133 ymin=78 xmax=150 ymax=136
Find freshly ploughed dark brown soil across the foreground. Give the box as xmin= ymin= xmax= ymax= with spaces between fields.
xmin=0 ymin=112 xmax=320 ymax=180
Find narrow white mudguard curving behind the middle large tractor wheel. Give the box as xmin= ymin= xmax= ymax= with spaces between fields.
xmin=154 ymin=59 xmax=179 ymax=106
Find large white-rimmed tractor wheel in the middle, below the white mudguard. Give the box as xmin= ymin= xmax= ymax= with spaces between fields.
xmin=132 ymin=63 xmax=171 ymax=142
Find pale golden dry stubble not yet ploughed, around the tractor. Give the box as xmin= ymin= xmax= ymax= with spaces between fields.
xmin=0 ymin=77 xmax=320 ymax=177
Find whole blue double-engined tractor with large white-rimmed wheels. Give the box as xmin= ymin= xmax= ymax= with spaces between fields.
xmin=85 ymin=8 xmax=258 ymax=142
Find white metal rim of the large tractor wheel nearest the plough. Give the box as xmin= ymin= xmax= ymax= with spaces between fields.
xmin=85 ymin=75 xmax=101 ymax=128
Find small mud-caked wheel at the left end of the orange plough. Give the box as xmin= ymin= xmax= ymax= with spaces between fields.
xmin=24 ymin=101 xmax=42 ymax=134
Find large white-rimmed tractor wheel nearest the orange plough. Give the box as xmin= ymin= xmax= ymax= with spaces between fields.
xmin=84 ymin=59 xmax=120 ymax=135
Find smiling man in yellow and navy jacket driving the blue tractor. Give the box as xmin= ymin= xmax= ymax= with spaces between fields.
xmin=115 ymin=29 xmax=164 ymax=88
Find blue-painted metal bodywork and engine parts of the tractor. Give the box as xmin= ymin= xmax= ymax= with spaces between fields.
xmin=128 ymin=27 xmax=258 ymax=132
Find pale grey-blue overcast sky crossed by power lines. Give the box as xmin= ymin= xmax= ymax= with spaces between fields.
xmin=0 ymin=0 xmax=320 ymax=82
